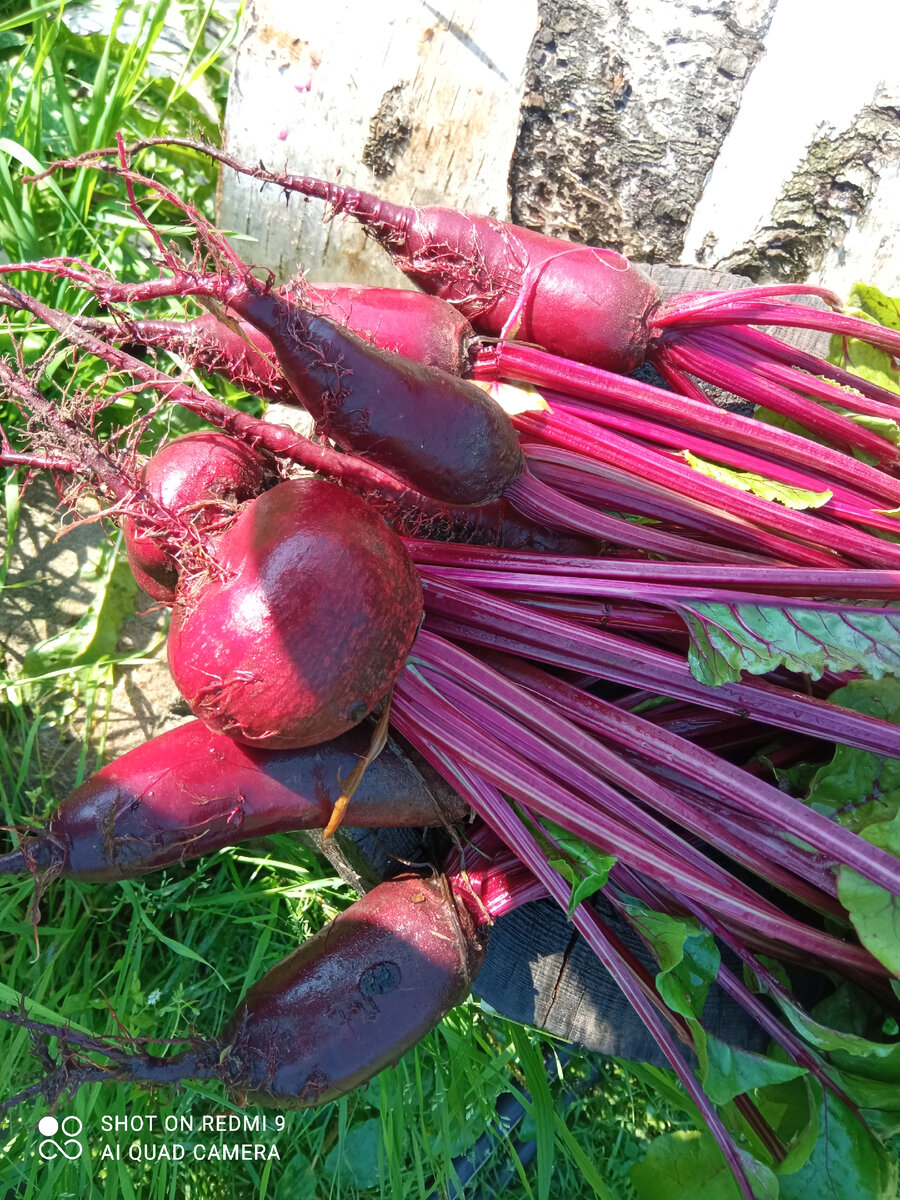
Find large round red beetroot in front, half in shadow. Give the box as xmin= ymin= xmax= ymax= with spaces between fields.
xmin=169 ymin=479 xmax=422 ymax=749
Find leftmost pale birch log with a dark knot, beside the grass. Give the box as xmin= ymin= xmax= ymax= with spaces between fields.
xmin=220 ymin=0 xmax=538 ymax=286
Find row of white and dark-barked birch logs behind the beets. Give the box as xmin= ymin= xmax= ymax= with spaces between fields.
xmin=221 ymin=0 xmax=900 ymax=294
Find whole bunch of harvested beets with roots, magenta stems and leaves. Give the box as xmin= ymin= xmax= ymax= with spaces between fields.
xmin=0 ymin=146 xmax=900 ymax=1198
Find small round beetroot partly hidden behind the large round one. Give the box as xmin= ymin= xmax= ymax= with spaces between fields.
xmin=122 ymin=432 xmax=276 ymax=602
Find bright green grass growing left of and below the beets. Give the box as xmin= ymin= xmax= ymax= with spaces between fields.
xmin=0 ymin=0 xmax=682 ymax=1200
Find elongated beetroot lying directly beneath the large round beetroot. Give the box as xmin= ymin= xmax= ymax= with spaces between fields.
xmin=0 ymin=721 xmax=466 ymax=880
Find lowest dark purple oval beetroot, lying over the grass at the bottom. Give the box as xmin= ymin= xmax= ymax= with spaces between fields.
xmin=220 ymin=876 xmax=487 ymax=1109
